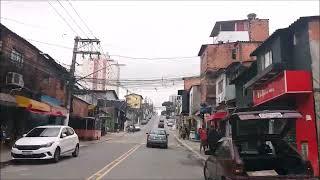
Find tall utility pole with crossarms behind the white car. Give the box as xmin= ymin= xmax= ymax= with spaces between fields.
xmin=65 ymin=36 xmax=100 ymax=125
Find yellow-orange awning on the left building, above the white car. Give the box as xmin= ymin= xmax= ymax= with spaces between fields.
xmin=15 ymin=96 xmax=51 ymax=112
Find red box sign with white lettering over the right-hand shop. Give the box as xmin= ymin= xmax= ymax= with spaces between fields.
xmin=253 ymin=71 xmax=312 ymax=106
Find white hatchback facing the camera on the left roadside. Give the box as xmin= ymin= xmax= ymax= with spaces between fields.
xmin=11 ymin=125 xmax=79 ymax=162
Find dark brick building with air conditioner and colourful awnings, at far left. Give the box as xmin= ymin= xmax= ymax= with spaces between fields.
xmin=0 ymin=24 xmax=69 ymax=136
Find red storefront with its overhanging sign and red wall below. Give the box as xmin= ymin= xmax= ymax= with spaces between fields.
xmin=253 ymin=70 xmax=319 ymax=176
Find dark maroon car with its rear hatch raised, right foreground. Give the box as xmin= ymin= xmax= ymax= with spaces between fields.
xmin=204 ymin=111 xmax=313 ymax=180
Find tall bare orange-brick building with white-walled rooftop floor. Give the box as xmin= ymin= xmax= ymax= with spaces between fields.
xmin=198 ymin=14 xmax=269 ymax=106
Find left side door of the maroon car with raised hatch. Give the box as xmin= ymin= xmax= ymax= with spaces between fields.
xmin=214 ymin=140 xmax=233 ymax=179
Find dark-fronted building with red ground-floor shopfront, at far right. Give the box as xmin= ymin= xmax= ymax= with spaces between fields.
xmin=244 ymin=16 xmax=320 ymax=175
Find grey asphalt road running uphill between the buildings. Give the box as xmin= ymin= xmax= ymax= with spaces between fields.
xmin=0 ymin=117 xmax=203 ymax=180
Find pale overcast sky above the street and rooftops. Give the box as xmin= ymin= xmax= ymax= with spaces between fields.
xmin=1 ymin=0 xmax=319 ymax=106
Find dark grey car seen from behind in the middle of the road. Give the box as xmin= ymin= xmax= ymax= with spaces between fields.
xmin=146 ymin=129 xmax=169 ymax=148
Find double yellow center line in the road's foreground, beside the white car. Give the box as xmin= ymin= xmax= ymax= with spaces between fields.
xmin=87 ymin=144 xmax=141 ymax=180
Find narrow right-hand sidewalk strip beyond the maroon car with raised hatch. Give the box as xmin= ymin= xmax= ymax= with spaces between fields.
xmin=171 ymin=130 xmax=209 ymax=163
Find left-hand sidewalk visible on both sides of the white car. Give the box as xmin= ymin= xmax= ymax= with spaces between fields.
xmin=0 ymin=132 xmax=126 ymax=168
